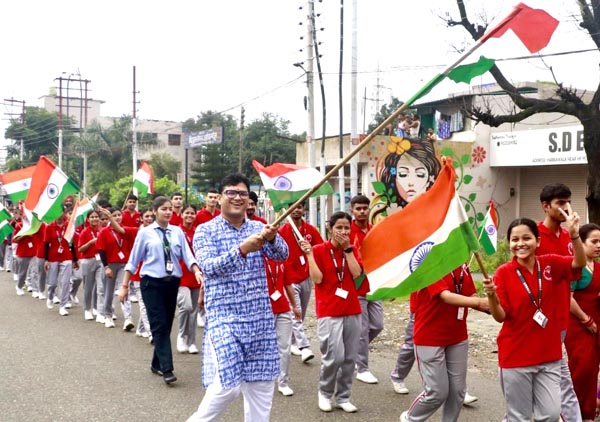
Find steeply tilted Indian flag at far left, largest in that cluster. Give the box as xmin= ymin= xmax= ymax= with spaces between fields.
xmin=25 ymin=155 xmax=79 ymax=223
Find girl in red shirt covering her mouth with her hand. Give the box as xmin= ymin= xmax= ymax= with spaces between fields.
xmin=300 ymin=211 xmax=364 ymax=413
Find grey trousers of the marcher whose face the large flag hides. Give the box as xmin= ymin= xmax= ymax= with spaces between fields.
xmin=408 ymin=340 xmax=469 ymax=422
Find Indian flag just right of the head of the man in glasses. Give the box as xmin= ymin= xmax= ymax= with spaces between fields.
xmin=252 ymin=160 xmax=334 ymax=211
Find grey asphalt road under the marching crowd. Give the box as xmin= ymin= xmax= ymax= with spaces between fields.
xmin=0 ymin=272 xmax=503 ymax=422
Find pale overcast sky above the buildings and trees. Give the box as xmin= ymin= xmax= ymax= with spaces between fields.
xmin=0 ymin=0 xmax=599 ymax=145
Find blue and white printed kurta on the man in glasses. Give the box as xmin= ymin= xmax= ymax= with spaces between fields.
xmin=193 ymin=216 xmax=288 ymax=389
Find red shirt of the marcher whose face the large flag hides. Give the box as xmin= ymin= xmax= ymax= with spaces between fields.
xmin=414 ymin=265 xmax=477 ymax=347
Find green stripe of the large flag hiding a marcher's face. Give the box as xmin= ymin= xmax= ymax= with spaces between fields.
xmin=367 ymin=222 xmax=479 ymax=300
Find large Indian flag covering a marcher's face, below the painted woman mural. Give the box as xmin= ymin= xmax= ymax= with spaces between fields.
xmin=361 ymin=160 xmax=479 ymax=300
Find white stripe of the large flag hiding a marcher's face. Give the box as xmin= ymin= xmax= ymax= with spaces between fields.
xmin=367 ymin=194 xmax=468 ymax=293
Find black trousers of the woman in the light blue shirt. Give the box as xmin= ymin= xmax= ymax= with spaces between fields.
xmin=140 ymin=276 xmax=179 ymax=372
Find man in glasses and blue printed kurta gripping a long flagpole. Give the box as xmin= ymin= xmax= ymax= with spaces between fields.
xmin=189 ymin=174 xmax=288 ymax=422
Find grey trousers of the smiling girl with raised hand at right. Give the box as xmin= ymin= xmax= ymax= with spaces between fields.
xmin=500 ymin=360 xmax=570 ymax=422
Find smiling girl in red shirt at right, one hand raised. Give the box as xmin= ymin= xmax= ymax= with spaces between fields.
xmin=483 ymin=214 xmax=586 ymax=420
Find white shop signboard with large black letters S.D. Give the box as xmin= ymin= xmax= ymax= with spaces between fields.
xmin=490 ymin=125 xmax=587 ymax=167
